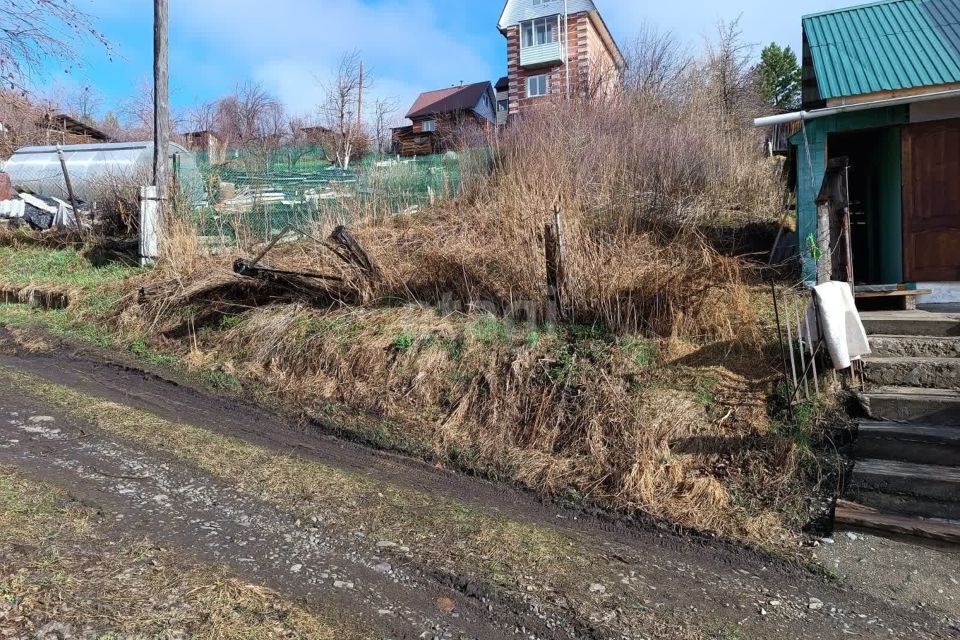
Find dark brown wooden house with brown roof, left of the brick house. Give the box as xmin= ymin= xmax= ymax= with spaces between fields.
xmin=393 ymin=82 xmax=496 ymax=156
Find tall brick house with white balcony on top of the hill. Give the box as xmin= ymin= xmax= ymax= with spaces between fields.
xmin=498 ymin=0 xmax=626 ymax=116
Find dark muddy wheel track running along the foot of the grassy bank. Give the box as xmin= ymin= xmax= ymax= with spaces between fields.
xmin=0 ymin=330 xmax=957 ymax=638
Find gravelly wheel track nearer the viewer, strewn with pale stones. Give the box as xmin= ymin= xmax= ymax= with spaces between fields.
xmin=0 ymin=396 xmax=583 ymax=640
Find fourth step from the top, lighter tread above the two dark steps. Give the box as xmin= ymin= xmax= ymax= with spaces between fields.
xmin=860 ymin=387 xmax=960 ymax=425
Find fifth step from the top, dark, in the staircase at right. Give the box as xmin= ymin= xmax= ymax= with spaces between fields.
xmin=853 ymin=422 xmax=960 ymax=466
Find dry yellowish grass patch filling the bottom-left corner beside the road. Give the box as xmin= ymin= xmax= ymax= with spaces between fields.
xmin=0 ymin=467 xmax=366 ymax=640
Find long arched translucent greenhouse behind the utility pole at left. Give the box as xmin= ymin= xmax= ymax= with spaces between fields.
xmin=2 ymin=142 xmax=203 ymax=203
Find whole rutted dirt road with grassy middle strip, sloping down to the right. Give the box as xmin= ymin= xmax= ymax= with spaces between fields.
xmin=0 ymin=335 xmax=960 ymax=640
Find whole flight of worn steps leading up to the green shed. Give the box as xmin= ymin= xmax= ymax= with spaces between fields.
xmin=836 ymin=311 xmax=960 ymax=543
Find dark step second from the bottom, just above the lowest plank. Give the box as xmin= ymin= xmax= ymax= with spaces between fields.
xmin=848 ymin=458 xmax=960 ymax=520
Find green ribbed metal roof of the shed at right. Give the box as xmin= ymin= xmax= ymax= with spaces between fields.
xmin=803 ymin=0 xmax=960 ymax=100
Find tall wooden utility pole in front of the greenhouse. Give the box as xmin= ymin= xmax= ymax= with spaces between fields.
xmin=153 ymin=0 xmax=170 ymax=217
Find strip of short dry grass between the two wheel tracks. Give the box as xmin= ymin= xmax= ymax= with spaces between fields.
xmin=0 ymin=369 xmax=705 ymax=640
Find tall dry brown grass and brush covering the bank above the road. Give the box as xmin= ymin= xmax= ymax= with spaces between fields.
xmin=95 ymin=92 xmax=824 ymax=544
